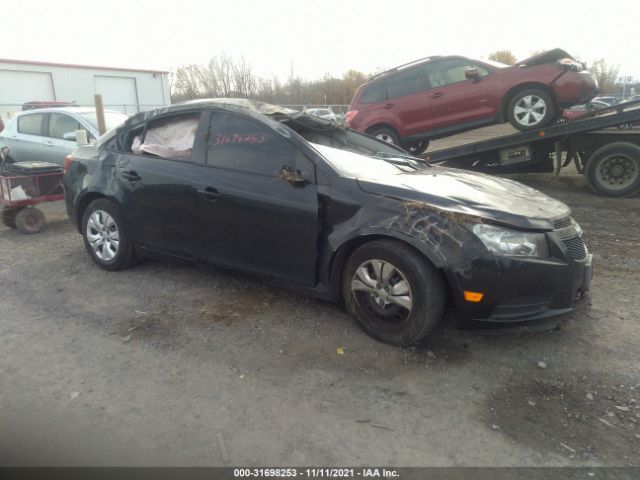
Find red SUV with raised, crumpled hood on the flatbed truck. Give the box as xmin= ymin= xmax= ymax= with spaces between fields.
xmin=345 ymin=49 xmax=598 ymax=154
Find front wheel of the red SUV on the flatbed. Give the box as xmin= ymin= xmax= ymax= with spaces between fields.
xmin=507 ymin=88 xmax=555 ymax=131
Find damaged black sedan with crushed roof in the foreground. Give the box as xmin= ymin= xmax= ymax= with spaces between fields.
xmin=64 ymin=99 xmax=592 ymax=345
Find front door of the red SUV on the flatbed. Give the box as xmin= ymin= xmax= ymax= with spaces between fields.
xmin=427 ymin=58 xmax=500 ymax=129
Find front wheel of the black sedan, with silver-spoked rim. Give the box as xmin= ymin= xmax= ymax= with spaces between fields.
xmin=342 ymin=240 xmax=446 ymax=346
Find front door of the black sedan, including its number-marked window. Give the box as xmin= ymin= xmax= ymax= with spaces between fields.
xmin=198 ymin=110 xmax=318 ymax=285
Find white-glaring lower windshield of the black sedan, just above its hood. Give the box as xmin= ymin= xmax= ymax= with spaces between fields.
xmin=311 ymin=143 xmax=426 ymax=180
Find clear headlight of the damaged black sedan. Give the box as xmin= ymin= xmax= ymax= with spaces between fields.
xmin=473 ymin=223 xmax=549 ymax=258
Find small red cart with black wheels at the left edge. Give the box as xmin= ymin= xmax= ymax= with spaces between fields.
xmin=0 ymin=152 xmax=64 ymax=233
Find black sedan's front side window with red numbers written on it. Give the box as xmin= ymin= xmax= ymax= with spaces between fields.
xmin=207 ymin=111 xmax=313 ymax=177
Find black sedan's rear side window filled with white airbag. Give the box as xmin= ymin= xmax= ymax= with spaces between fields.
xmin=127 ymin=112 xmax=201 ymax=160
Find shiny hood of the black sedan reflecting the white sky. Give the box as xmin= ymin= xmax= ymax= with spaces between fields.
xmin=357 ymin=167 xmax=571 ymax=230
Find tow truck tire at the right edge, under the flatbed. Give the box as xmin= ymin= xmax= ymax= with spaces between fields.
xmin=584 ymin=142 xmax=640 ymax=197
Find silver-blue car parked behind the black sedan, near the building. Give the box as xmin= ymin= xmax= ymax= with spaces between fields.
xmin=0 ymin=107 xmax=128 ymax=165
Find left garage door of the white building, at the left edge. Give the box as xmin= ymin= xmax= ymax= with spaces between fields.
xmin=0 ymin=70 xmax=55 ymax=114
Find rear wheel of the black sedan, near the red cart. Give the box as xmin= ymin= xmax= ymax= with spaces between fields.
xmin=82 ymin=198 xmax=136 ymax=270
